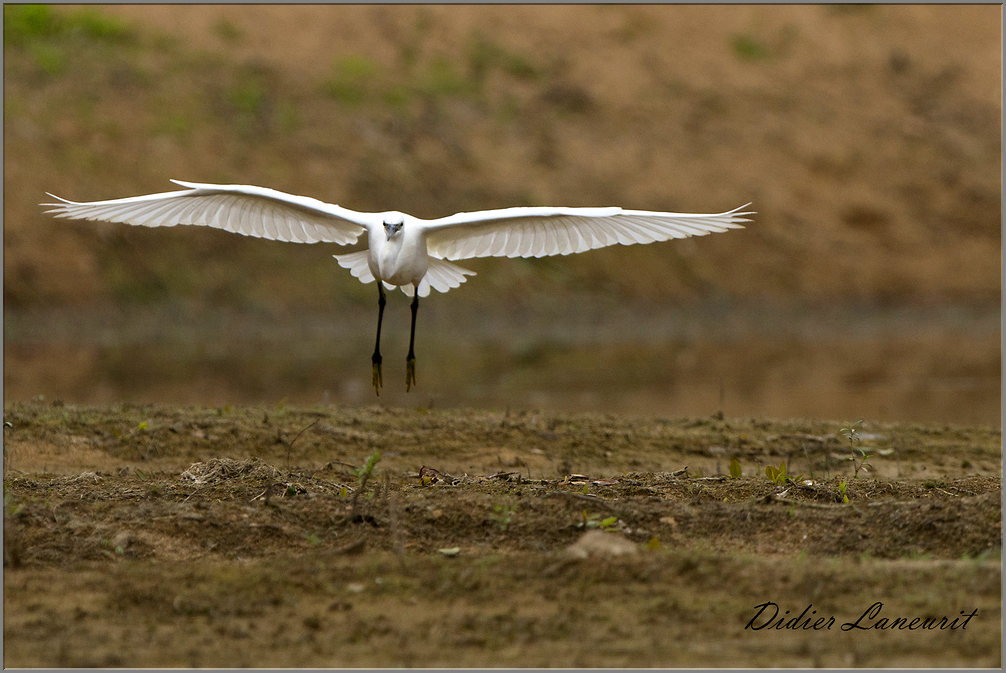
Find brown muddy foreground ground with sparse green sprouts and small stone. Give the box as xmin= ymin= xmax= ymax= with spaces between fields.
xmin=4 ymin=403 xmax=1002 ymax=667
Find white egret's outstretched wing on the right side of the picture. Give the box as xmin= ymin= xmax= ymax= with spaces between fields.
xmin=423 ymin=203 xmax=753 ymax=260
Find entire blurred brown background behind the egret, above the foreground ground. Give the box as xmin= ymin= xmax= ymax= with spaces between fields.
xmin=3 ymin=5 xmax=1002 ymax=427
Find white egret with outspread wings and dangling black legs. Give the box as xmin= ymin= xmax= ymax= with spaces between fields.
xmin=41 ymin=180 xmax=753 ymax=395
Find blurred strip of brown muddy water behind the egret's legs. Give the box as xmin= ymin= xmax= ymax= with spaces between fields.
xmin=4 ymin=296 xmax=1002 ymax=427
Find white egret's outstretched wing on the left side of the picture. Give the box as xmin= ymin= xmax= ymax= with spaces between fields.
xmin=41 ymin=180 xmax=380 ymax=244
